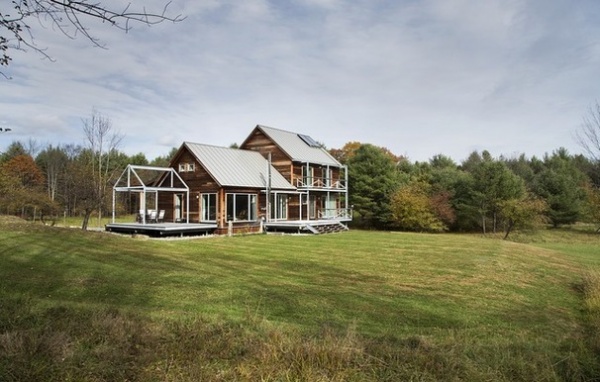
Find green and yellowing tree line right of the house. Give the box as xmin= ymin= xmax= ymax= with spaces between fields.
xmin=330 ymin=142 xmax=600 ymax=238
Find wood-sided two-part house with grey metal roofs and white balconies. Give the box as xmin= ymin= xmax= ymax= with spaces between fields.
xmin=107 ymin=125 xmax=352 ymax=234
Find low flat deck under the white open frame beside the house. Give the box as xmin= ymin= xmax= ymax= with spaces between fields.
xmin=105 ymin=223 xmax=217 ymax=236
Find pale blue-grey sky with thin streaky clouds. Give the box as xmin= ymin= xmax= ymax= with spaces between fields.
xmin=0 ymin=0 xmax=600 ymax=162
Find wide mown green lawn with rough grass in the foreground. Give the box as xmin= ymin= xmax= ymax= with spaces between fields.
xmin=0 ymin=217 xmax=600 ymax=381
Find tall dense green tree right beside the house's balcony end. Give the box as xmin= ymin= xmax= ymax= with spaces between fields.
xmin=348 ymin=144 xmax=398 ymax=228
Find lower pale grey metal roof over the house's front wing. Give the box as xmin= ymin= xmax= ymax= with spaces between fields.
xmin=183 ymin=142 xmax=295 ymax=190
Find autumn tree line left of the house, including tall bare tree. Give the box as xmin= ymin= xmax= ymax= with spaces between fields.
xmin=0 ymin=111 xmax=177 ymax=229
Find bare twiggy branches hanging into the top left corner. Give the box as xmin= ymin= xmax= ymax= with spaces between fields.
xmin=0 ymin=0 xmax=184 ymax=73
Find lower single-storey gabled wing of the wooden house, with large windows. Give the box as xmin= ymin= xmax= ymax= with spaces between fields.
xmin=158 ymin=142 xmax=296 ymax=233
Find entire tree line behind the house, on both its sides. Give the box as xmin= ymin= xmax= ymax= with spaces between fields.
xmin=0 ymin=109 xmax=600 ymax=237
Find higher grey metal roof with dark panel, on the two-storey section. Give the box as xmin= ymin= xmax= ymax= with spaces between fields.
xmin=247 ymin=125 xmax=342 ymax=167
